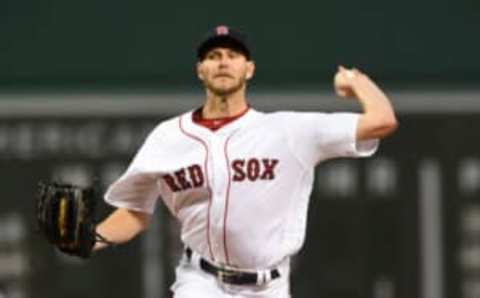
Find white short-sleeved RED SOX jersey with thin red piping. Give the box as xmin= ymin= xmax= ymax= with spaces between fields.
xmin=105 ymin=109 xmax=378 ymax=269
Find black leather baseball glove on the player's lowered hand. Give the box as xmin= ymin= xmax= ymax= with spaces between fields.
xmin=36 ymin=182 xmax=109 ymax=258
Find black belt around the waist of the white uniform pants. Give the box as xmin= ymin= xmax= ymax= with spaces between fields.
xmin=185 ymin=247 xmax=280 ymax=285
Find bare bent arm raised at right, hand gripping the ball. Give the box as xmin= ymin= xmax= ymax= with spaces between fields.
xmin=334 ymin=66 xmax=398 ymax=141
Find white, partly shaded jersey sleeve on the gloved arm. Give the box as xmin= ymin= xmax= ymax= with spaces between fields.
xmin=104 ymin=123 xmax=165 ymax=214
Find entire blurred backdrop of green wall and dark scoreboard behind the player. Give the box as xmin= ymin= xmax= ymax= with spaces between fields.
xmin=0 ymin=0 xmax=480 ymax=298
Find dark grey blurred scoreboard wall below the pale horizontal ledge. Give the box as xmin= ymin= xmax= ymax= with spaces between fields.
xmin=0 ymin=113 xmax=480 ymax=298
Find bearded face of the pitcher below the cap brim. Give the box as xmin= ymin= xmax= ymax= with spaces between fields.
xmin=197 ymin=48 xmax=254 ymax=96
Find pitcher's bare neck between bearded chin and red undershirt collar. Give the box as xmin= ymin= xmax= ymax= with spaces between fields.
xmin=202 ymin=90 xmax=248 ymax=119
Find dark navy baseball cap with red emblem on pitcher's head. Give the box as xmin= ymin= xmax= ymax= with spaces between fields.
xmin=197 ymin=25 xmax=251 ymax=61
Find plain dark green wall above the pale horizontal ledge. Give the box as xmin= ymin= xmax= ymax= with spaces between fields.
xmin=0 ymin=0 xmax=480 ymax=89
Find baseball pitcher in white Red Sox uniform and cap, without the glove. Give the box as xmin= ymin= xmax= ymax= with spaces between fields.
xmin=46 ymin=26 xmax=397 ymax=298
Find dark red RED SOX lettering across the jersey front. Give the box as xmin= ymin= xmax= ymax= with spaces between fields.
xmin=163 ymin=158 xmax=278 ymax=192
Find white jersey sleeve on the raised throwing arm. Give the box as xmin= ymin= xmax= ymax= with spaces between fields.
xmin=283 ymin=113 xmax=379 ymax=165
